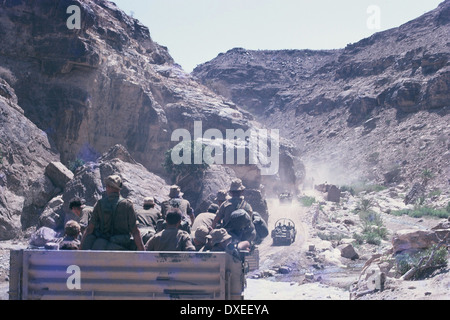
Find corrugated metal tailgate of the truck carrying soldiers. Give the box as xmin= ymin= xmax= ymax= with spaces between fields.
xmin=14 ymin=250 xmax=240 ymax=300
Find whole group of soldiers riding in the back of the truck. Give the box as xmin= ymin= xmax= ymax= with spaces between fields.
xmin=52 ymin=175 xmax=264 ymax=252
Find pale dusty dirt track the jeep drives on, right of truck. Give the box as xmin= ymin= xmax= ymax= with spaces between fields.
xmin=244 ymin=199 xmax=349 ymax=300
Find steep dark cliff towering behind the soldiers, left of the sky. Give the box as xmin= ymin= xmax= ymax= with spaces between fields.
xmin=0 ymin=0 xmax=301 ymax=192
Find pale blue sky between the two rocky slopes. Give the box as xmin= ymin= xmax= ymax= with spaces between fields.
xmin=113 ymin=0 xmax=443 ymax=72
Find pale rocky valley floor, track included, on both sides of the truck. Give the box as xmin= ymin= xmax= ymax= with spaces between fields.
xmin=0 ymin=186 xmax=450 ymax=300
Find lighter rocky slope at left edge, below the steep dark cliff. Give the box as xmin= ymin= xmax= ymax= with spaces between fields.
xmin=0 ymin=76 xmax=60 ymax=240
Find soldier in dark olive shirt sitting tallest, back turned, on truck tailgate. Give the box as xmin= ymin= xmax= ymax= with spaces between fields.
xmin=81 ymin=175 xmax=145 ymax=251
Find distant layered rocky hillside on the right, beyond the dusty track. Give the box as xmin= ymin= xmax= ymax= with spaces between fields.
xmin=193 ymin=0 xmax=450 ymax=190
